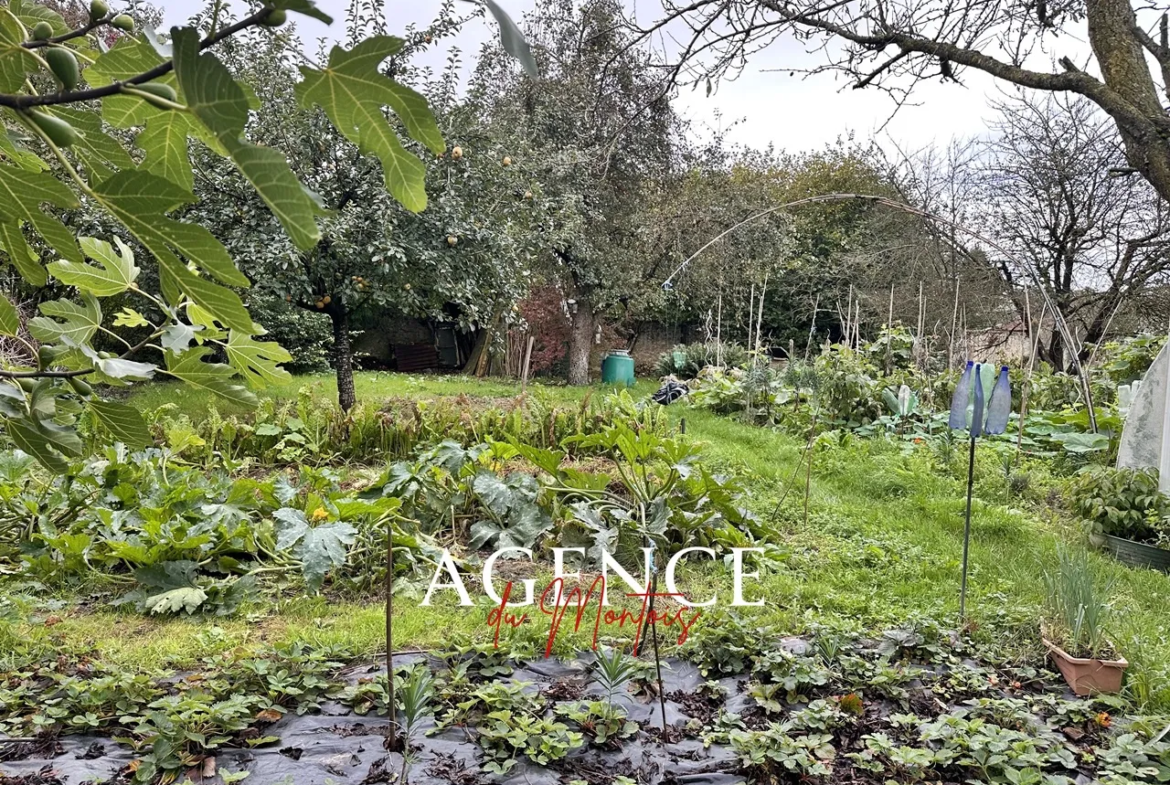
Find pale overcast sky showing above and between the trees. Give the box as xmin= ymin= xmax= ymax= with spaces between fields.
xmin=164 ymin=0 xmax=1088 ymax=151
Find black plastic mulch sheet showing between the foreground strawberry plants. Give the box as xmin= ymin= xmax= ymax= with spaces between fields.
xmin=0 ymin=653 xmax=746 ymax=785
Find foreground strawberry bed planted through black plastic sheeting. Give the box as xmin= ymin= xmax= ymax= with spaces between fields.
xmin=0 ymin=619 xmax=1170 ymax=785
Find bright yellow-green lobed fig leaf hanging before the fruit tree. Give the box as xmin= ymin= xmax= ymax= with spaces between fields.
xmin=296 ymin=35 xmax=445 ymax=212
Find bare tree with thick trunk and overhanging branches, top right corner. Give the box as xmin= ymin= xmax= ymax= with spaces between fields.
xmin=639 ymin=0 xmax=1170 ymax=200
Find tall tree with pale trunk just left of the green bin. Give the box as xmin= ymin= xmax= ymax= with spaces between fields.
xmin=472 ymin=0 xmax=677 ymax=384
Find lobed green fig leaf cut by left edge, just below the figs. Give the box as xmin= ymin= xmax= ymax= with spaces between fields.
xmin=0 ymin=165 xmax=82 ymax=273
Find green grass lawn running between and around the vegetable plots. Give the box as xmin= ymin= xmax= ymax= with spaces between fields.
xmin=22 ymin=373 xmax=1170 ymax=707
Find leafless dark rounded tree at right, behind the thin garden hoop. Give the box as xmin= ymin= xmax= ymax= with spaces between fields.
xmin=982 ymin=95 xmax=1170 ymax=369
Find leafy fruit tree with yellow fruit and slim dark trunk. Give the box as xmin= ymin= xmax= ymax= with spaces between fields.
xmin=195 ymin=4 xmax=531 ymax=409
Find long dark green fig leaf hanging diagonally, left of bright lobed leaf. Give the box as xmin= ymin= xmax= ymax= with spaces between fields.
xmin=171 ymin=27 xmax=321 ymax=250
